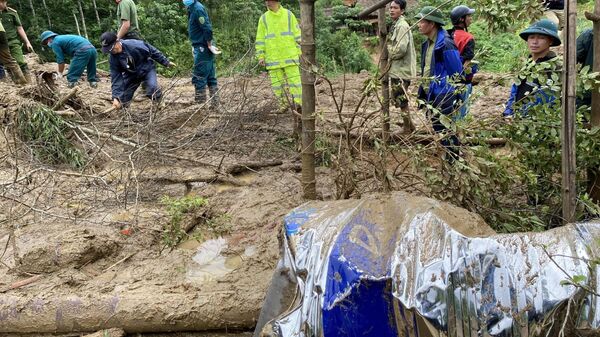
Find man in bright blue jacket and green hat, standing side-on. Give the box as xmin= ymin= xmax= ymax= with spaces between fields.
xmin=415 ymin=6 xmax=463 ymax=161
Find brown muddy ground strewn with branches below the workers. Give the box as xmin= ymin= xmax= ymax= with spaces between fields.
xmin=0 ymin=53 xmax=508 ymax=336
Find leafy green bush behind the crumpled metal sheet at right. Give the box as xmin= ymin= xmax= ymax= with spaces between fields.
xmin=410 ymin=55 xmax=600 ymax=232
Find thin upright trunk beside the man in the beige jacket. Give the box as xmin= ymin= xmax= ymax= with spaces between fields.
xmin=378 ymin=7 xmax=390 ymax=144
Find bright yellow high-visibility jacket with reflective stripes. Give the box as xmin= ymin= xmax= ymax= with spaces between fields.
xmin=255 ymin=6 xmax=300 ymax=69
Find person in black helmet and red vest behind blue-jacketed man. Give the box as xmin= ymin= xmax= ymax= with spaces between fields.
xmin=448 ymin=5 xmax=477 ymax=119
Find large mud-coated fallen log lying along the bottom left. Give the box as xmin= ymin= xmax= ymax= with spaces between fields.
xmin=0 ymin=291 xmax=258 ymax=335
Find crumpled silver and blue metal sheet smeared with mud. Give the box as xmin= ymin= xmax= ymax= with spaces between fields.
xmin=264 ymin=193 xmax=600 ymax=337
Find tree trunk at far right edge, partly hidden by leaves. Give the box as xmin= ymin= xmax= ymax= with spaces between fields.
xmin=585 ymin=0 xmax=600 ymax=203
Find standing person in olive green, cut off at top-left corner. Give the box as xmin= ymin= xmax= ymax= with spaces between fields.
xmin=0 ymin=0 xmax=33 ymax=82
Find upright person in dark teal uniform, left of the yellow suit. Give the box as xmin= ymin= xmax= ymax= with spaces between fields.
xmin=183 ymin=0 xmax=219 ymax=108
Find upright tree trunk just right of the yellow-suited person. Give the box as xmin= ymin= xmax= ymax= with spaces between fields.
xmin=300 ymin=0 xmax=317 ymax=200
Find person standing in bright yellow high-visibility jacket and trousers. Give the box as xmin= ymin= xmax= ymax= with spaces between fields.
xmin=255 ymin=0 xmax=302 ymax=111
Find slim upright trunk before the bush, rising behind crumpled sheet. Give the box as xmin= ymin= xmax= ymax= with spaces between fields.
xmin=561 ymin=0 xmax=577 ymax=224
